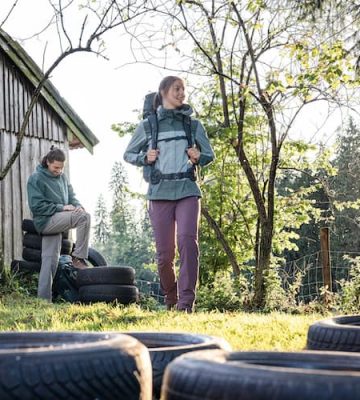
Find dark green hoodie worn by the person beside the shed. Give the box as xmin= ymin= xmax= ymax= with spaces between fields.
xmin=27 ymin=164 xmax=81 ymax=233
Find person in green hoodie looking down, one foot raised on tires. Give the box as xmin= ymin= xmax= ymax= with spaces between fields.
xmin=27 ymin=146 xmax=90 ymax=302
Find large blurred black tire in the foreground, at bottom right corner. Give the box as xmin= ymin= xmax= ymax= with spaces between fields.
xmin=161 ymin=350 xmax=360 ymax=400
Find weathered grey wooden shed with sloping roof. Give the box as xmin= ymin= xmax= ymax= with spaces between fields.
xmin=0 ymin=29 xmax=98 ymax=270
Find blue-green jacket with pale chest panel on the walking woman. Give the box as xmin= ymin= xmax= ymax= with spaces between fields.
xmin=124 ymin=105 xmax=214 ymax=200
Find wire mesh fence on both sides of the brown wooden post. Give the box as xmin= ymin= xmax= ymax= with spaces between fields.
xmin=279 ymin=251 xmax=360 ymax=302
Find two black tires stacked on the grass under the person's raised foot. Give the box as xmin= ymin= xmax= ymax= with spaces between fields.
xmin=77 ymin=266 xmax=139 ymax=304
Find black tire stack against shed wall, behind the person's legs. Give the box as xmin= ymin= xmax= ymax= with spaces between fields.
xmin=11 ymin=219 xmax=74 ymax=273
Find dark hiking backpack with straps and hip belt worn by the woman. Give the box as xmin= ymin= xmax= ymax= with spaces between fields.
xmin=143 ymin=92 xmax=198 ymax=185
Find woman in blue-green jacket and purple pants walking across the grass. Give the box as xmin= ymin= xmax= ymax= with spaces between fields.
xmin=124 ymin=76 xmax=214 ymax=313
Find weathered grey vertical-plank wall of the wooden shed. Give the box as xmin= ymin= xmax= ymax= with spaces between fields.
xmin=0 ymin=50 xmax=68 ymax=269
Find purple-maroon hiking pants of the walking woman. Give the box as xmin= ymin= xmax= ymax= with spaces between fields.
xmin=149 ymin=197 xmax=200 ymax=310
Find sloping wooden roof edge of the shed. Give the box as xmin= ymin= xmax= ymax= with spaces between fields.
xmin=0 ymin=29 xmax=99 ymax=153
